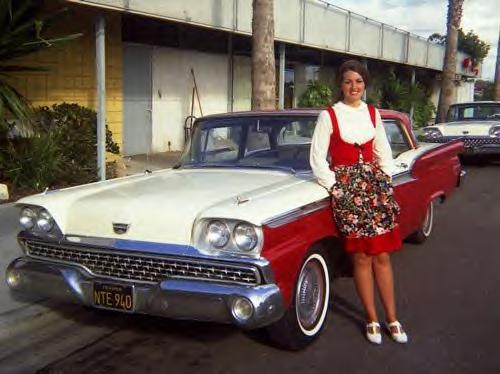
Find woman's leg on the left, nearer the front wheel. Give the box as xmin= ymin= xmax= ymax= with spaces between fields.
xmin=352 ymin=253 xmax=378 ymax=322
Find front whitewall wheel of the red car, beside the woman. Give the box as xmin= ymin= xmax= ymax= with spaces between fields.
xmin=267 ymin=249 xmax=330 ymax=350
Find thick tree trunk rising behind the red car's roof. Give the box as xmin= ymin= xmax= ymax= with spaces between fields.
xmin=252 ymin=0 xmax=276 ymax=110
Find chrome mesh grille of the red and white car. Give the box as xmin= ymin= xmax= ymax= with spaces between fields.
xmin=25 ymin=240 xmax=260 ymax=285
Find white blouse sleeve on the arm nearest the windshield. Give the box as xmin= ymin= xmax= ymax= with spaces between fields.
xmin=309 ymin=110 xmax=335 ymax=189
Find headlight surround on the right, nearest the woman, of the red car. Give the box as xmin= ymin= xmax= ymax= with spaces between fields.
xmin=193 ymin=218 xmax=264 ymax=257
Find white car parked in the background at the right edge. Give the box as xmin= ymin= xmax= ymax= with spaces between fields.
xmin=424 ymin=101 xmax=500 ymax=155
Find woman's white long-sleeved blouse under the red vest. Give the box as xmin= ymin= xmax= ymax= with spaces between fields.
xmin=310 ymin=101 xmax=394 ymax=188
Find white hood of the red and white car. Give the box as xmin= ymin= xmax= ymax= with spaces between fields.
xmin=18 ymin=169 xmax=327 ymax=244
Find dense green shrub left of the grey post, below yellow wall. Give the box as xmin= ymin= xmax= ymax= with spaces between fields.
xmin=0 ymin=103 xmax=119 ymax=191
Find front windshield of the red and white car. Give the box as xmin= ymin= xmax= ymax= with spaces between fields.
xmin=179 ymin=116 xmax=316 ymax=173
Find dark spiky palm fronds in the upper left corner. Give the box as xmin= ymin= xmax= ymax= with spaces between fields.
xmin=0 ymin=0 xmax=81 ymax=121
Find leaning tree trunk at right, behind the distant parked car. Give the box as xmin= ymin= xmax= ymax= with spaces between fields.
xmin=436 ymin=0 xmax=464 ymax=123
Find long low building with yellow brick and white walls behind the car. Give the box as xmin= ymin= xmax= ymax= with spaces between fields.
xmin=8 ymin=0 xmax=476 ymax=155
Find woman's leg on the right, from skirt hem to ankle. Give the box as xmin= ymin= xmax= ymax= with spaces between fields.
xmin=373 ymin=253 xmax=397 ymax=322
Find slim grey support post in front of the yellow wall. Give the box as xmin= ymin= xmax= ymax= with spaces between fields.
xmin=95 ymin=15 xmax=106 ymax=180
